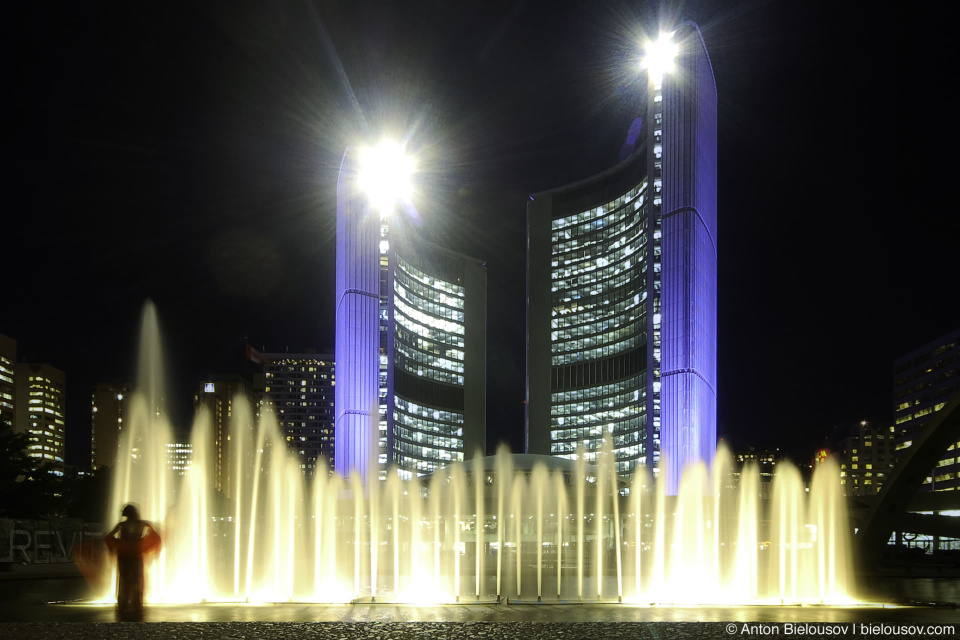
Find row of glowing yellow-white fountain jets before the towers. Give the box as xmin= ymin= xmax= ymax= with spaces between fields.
xmin=110 ymin=305 xmax=853 ymax=604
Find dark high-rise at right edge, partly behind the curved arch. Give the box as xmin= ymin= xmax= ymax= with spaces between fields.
xmin=893 ymin=329 xmax=960 ymax=491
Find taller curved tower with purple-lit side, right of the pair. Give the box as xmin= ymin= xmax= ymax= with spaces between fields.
xmin=526 ymin=18 xmax=717 ymax=493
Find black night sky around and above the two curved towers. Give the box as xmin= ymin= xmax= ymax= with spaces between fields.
xmin=0 ymin=0 xmax=960 ymax=465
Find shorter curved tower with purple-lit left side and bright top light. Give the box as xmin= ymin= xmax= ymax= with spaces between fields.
xmin=335 ymin=149 xmax=487 ymax=477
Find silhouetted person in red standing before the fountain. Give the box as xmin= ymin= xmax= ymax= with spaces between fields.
xmin=104 ymin=504 xmax=160 ymax=613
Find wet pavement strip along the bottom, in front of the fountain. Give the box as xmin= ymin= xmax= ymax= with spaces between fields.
xmin=0 ymin=577 xmax=960 ymax=640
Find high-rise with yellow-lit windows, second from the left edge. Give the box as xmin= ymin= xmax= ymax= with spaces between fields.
xmin=14 ymin=362 xmax=66 ymax=474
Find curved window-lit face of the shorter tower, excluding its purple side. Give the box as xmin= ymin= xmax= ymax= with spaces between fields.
xmin=386 ymin=233 xmax=487 ymax=475
